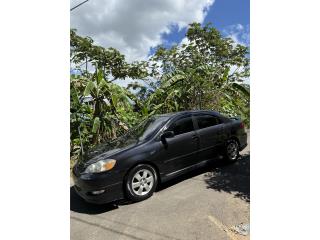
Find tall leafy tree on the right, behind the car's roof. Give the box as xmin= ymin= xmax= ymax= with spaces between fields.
xmin=149 ymin=23 xmax=250 ymax=122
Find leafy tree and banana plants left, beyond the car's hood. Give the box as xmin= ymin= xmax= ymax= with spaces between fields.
xmin=70 ymin=30 xmax=147 ymax=165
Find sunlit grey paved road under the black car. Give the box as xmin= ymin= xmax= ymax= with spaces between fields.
xmin=70 ymin=132 xmax=250 ymax=240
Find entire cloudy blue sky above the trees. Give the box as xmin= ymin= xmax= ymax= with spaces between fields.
xmin=70 ymin=0 xmax=250 ymax=62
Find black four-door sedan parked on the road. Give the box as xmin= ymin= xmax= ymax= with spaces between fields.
xmin=73 ymin=111 xmax=247 ymax=204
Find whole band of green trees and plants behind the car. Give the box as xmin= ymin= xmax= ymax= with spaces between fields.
xmin=70 ymin=23 xmax=250 ymax=165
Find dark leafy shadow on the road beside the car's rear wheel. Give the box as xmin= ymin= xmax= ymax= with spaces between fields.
xmin=204 ymin=153 xmax=250 ymax=202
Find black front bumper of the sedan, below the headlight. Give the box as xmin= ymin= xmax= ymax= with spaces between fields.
xmin=73 ymin=169 xmax=124 ymax=204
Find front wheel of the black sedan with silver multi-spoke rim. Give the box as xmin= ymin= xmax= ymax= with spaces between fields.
xmin=125 ymin=164 xmax=158 ymax=202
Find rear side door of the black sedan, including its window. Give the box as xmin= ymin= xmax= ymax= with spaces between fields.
xmin=194 ymin=114 xmax=224 ymax=161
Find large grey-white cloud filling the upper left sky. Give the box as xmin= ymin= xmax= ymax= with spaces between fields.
xmin=70 ymin=0 xmax=214 ymax=61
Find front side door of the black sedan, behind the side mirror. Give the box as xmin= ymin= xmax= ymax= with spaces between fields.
xmin=160 ymin=115 xmax=200 ymax=174
